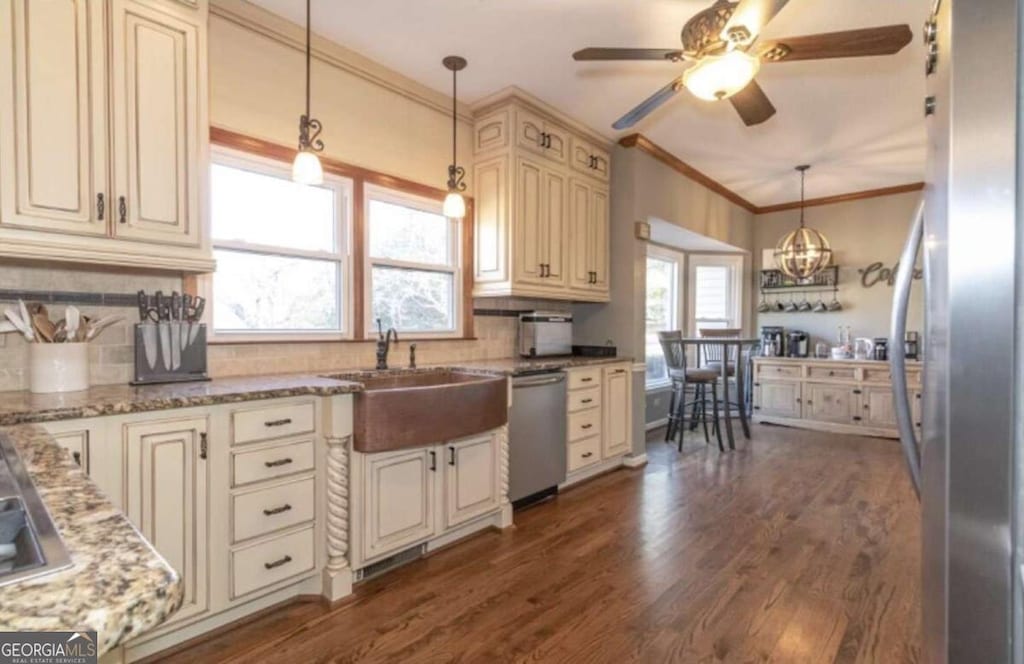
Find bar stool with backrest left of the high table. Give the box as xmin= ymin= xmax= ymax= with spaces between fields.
xmin=658 ymin=330 xmax=725 ymax=452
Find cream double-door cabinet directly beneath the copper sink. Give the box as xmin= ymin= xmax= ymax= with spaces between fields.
xmin=351 ymin=427 xmax=508 ymax=569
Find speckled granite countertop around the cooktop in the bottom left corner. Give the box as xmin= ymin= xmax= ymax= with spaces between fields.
xmin=0 ymin=424 xmax=182 ymax=655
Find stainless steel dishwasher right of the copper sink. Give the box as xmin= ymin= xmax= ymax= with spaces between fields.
xmin=509 ymin=371 xmax=566 ymax=507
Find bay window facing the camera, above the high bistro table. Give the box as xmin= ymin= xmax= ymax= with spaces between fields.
xmin=688 ymin=254 xmax=743 ymax=335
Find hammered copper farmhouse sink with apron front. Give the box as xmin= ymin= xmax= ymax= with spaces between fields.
xmin=327 ymin=370 xmax=508 ymax=452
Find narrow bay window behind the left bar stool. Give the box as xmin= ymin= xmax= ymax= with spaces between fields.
xmin=644 ymin=247 xmax=682 ymax=389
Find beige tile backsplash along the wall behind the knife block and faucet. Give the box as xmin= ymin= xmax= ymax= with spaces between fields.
xmin=0 ymin=264 xmax=569 ymax=390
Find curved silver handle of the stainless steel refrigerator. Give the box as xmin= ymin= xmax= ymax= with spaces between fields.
xmin=889 ymin=199 xmax=928 ymax=498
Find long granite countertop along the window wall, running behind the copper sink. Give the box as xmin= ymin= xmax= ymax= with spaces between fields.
xmin=0 ymin=356 xmax=632 ymax=426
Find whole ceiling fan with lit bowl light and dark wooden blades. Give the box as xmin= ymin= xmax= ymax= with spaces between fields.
xmin=572 ymin=0 xmax=913 ymax=129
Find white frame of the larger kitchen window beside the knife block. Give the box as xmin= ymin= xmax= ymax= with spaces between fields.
xmin=201 ymin=143 xmax=355 ymax=342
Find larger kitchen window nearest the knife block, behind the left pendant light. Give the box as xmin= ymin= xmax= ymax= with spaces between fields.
xmin=210 ymin=149 xmax=351 ymax=337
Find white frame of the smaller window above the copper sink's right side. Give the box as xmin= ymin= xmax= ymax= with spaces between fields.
xmin=362 ymin=183 xmax=468 ymax=339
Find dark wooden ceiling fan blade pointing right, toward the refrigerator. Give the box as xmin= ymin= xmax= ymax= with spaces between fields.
xmin=758 ymin=25 xmax=913 ymax=63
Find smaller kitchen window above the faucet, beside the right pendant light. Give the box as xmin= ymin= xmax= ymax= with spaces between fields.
xmin=366 ymin=185 xmax=462 ymax=336
